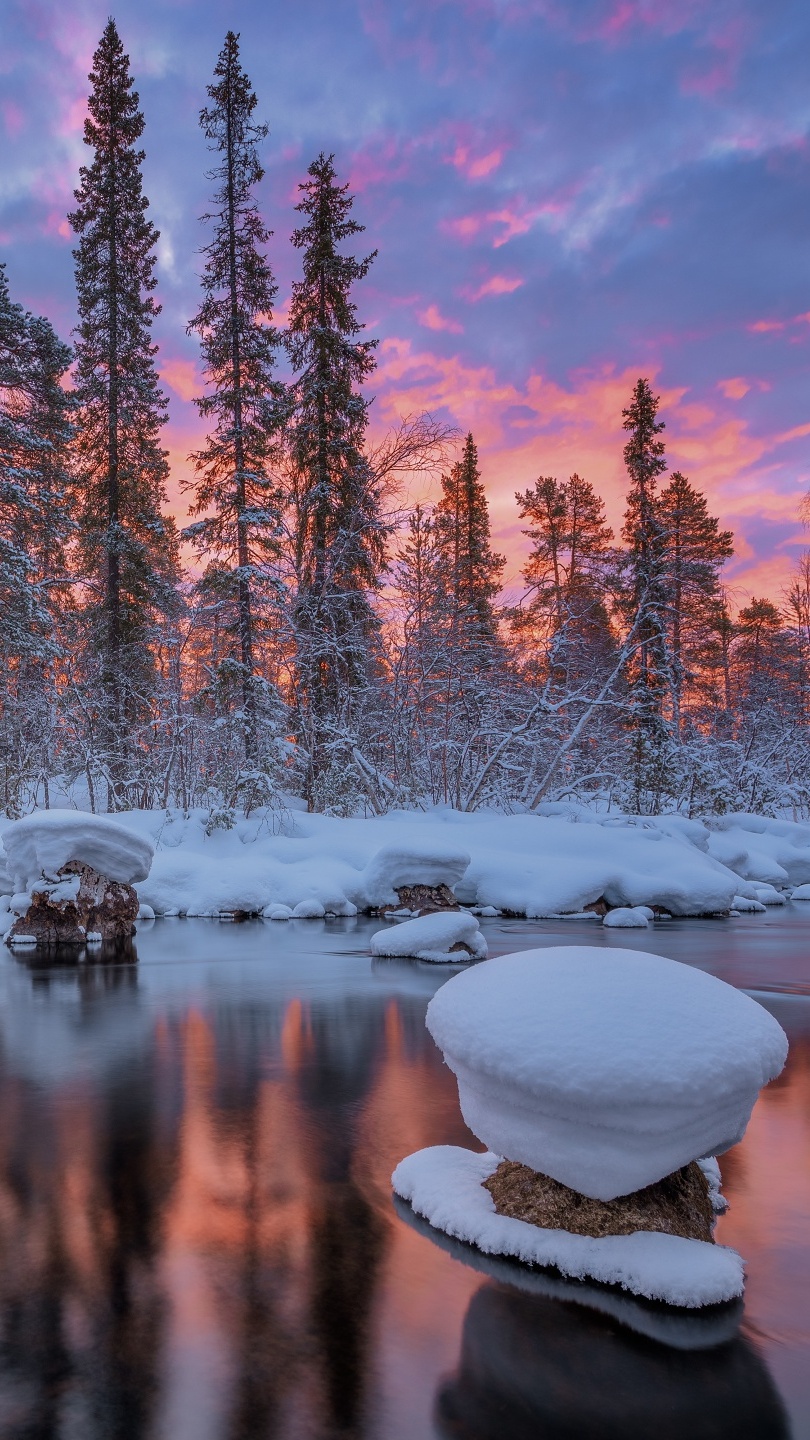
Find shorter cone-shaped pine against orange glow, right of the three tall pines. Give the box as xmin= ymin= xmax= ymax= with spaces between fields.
xmin=434 ymin=435 xmax=506 ymax=662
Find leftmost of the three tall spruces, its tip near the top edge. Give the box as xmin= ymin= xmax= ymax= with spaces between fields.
xmin=69 ymin=20 xmax=177 ymax=808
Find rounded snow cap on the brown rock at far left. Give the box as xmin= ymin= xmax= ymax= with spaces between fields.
xmin=3 ymin=809 xmax=154 ymax=891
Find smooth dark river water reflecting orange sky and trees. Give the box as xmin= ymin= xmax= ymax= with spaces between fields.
xmin=0 ymin=904 xmax=810 ymax=1440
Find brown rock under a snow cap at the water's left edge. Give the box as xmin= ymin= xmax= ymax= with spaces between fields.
xmin=6 ymin=861 xmax=140 ymax=945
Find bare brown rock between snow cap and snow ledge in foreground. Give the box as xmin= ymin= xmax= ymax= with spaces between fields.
xmin=484 ymin=1161 xmax=715 ymax=1243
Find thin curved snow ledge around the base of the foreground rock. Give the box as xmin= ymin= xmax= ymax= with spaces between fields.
xmin=392 ymin=1140 xmax=744 ymax=1309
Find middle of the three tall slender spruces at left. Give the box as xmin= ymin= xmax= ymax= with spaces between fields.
xmin=186 ymin=30 xmax=285 ymax=769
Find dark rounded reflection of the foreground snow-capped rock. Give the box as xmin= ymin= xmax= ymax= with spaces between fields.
xmin=437 ymin=1280 xmax=788 ymax=1440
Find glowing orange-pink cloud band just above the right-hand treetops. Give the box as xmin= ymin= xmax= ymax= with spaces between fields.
xmin=375 ymin=338 xmax=810 ymax=603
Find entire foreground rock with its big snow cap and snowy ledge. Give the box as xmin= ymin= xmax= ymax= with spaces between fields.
xmin=393 ymin=946 xmax=787 ymax=1308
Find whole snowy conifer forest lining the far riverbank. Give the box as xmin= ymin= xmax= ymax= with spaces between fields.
xmin=0 ymin=20 xmax=810 ymax=829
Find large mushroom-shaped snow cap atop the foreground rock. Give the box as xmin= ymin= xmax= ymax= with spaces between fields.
xmin=427 ymin=946 xmax=787 ymax=1200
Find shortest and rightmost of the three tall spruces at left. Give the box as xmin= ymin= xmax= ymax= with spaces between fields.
xmin=287 ymin=154 xmax=388 ymax=805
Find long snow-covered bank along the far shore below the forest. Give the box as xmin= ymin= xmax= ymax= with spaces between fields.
xmin=0 ymin=805 xmax=810 ymax=917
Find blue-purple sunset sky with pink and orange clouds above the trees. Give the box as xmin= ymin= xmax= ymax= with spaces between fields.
xmin=0 ymin=0 xmax=810 ymax=603
